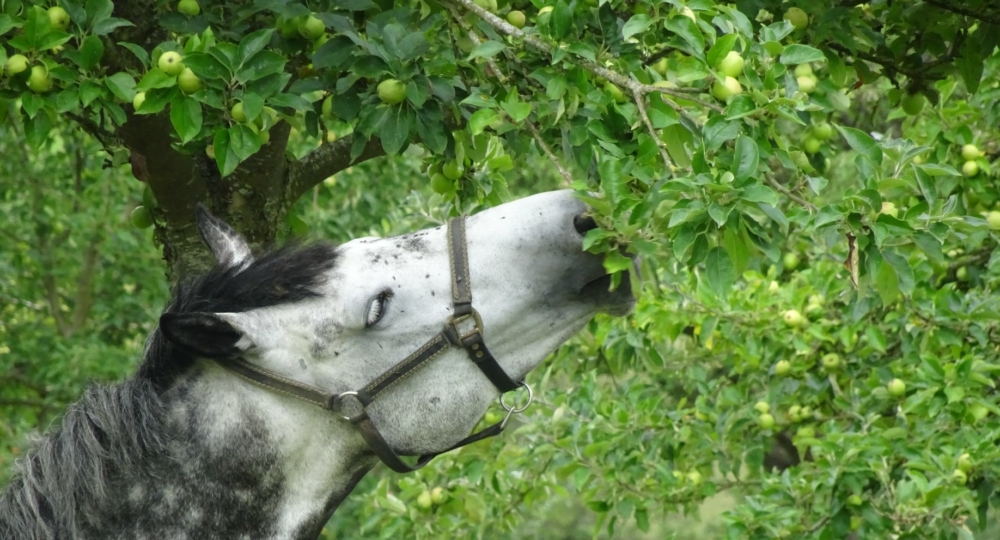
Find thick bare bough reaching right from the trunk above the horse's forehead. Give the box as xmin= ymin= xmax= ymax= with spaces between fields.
xmin=286 ymin=134 xmax=385 ymax=202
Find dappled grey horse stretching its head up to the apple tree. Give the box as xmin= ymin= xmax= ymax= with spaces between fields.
xmin=0 ymin=191 xmax=634 ymax=540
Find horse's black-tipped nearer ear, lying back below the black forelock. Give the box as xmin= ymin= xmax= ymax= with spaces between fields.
xmin=160 ymin=313 xmax=249 ymax=358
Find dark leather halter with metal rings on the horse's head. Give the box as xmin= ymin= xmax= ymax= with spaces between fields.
xmin=207 ymin=216 xmax=532 ymax=472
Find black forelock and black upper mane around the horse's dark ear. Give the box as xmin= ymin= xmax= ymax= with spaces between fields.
xmin=136 ymin=243 xmax=336 ymax=391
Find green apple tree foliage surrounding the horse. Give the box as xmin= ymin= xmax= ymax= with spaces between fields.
xmin=0 ymin=0 xmax=1000 ymax=538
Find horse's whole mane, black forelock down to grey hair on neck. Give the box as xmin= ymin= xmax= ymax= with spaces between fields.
xmin=0 ymin=243 xmax=336 ymax=540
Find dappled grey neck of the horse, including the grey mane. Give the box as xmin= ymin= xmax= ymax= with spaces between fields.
xmin=0 ymin=362 xmax=374 ymax=539
